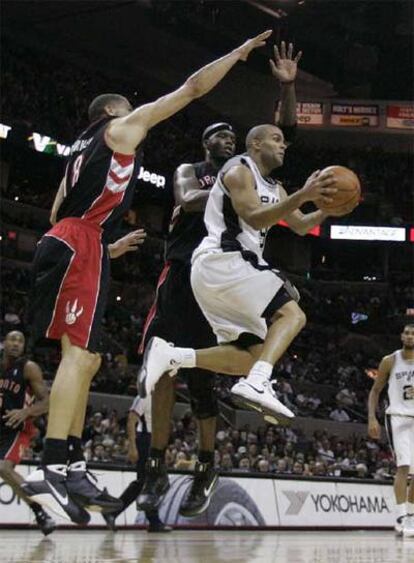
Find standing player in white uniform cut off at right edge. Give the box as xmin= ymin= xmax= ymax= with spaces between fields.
xmin=368 ymin=324 xmax=414 ymax=537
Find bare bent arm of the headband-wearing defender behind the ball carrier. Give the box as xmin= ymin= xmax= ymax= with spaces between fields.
xmin=174 ymin=164 xmax=210 ymax=215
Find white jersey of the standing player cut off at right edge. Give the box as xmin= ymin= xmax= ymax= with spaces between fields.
xmin=386 ymin=350 xmax=414 ymax=416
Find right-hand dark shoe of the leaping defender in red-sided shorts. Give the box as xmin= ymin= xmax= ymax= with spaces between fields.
xmin=66 ymin=461 xmax=123 ymax=512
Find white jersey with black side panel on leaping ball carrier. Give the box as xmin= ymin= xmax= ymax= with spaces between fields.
xmin=193 ymin=154 xmax=281 ymax=265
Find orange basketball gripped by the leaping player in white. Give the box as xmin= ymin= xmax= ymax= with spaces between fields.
xmin=318 ymin=166 xmax=361 ymax=217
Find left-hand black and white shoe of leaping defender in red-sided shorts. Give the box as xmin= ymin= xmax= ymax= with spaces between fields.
xmin=22 ymin=465 xmax=91 ymax=524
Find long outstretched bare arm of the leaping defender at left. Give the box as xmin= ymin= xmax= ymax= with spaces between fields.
xmin=106 ymin=30 xmax=272 ymax=154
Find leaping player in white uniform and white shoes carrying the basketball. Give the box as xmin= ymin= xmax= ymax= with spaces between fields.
xmin=139 ymin=125 xmax=351 ymax=421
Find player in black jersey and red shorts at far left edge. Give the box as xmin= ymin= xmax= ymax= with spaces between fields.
xmin=0 ymin=330 xmax=56 ymax=536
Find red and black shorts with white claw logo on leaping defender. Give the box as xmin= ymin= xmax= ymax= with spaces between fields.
xmin=30 ymin=217 xmax=109 ymax=352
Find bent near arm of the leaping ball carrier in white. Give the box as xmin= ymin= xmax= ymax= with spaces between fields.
xmin=224 ymin=165 xmax=336 ymax=230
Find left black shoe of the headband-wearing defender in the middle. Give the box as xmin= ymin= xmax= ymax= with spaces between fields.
xmin=138 ymin=457 xmax=170 ymax=512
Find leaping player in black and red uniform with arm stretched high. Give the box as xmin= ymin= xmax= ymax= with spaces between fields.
xmin=23 ymin=31 xmax=271 ymax=523
